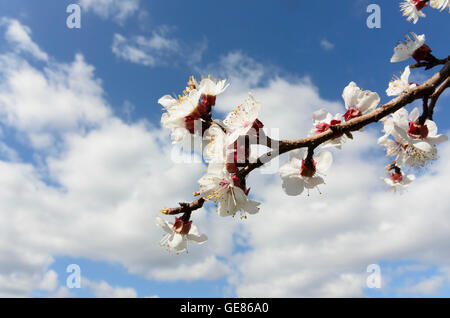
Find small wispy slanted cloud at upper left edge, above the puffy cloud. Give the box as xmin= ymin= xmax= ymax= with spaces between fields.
xmin=0 ymin=18 xmax=48 ymax=61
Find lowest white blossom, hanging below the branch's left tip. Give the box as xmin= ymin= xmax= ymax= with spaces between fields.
xmin=156 ymin=216 xmax=208 ymax=254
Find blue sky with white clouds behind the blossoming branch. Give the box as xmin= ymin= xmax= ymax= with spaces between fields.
xmin=0 ymin=0 xmax=450 ymax=297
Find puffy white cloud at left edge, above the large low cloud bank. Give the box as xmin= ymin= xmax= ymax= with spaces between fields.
xmin=0 ymin=50 xmax=110 ymax=148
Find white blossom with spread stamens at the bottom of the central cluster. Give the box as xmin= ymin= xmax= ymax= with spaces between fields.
xmin=199 ymin=162 xmax=260 ymax=217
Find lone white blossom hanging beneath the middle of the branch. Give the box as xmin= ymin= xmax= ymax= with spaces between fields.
xmin=279 ymin=148 xmax=333 ymax=196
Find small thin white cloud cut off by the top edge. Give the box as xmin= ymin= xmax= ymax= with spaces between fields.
xmin=79 ymin=0 xmax=140 ymax=24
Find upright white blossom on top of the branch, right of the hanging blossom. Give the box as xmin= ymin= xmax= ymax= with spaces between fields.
xmin=342 ymin=82 xmax=380 ymax=121
